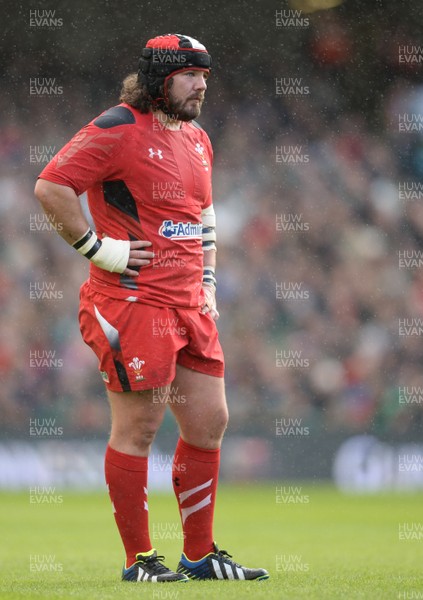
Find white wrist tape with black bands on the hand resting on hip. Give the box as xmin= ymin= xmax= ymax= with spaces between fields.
xmin=73 ymin=229 xmax=130 ymax=273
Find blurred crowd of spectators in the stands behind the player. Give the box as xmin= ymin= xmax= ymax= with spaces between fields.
xmin=0 ymin=3 xmax=423 ymax=436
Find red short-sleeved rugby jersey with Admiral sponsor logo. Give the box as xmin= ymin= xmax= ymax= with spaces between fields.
xmin=40 ymin=104 xmax=213 ymax=307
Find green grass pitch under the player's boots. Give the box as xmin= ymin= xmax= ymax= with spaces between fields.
xmin=0 ymin=483 xmax=423 ymax=600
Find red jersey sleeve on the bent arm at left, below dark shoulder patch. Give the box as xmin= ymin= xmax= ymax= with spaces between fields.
xmin=39 ymin=122 xmax=129 ymax=196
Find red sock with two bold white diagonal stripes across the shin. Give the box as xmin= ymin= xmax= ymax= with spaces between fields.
xmin=172 ymin=438 xmax=220 ymax=560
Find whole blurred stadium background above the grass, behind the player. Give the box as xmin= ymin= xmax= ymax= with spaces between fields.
xmin=0 ymin=0 xmax=423 ymax=489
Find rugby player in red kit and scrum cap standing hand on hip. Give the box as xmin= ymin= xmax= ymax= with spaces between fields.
xmin=35 ymin=34 xmax=268 ymax=582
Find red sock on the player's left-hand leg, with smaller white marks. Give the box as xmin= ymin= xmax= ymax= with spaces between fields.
xmin=104 ymin=446 xmax=152 ymax=567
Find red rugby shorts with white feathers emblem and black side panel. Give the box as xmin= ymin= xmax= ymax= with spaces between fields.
xmin=79 ymin=281 xmax=224 ymax=392
